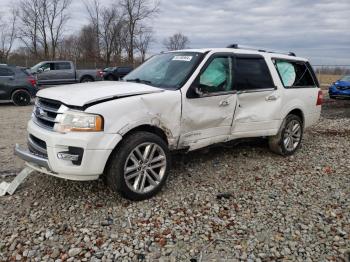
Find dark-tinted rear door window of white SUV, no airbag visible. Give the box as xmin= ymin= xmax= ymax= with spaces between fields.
xmin=234 ymin=56 xmax=275 ymax=91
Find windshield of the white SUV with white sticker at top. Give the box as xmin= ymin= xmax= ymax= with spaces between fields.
xmin=124 ymin=52 xmax=203 ymax=89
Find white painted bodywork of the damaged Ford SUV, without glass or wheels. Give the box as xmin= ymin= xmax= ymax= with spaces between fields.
xmin=19 ymin=49 xmax=321 ymax=180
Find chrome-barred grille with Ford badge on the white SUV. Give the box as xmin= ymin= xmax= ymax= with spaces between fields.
xmin=33 ymin=98 xmax=62 ymax=130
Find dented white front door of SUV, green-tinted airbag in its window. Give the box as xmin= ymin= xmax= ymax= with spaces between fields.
xmin=180 ymin=53 xmax=237 ymax=149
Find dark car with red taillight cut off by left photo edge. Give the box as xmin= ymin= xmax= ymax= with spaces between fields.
xmin=0 ymin=64 xmax=38 ymax=106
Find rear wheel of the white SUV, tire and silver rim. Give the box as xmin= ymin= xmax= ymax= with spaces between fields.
xmin=269 ymin=115 xmax=303 ymax=156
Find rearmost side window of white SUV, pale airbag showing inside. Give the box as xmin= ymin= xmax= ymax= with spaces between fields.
xmin=273 ymin=59 xmax=317 ymax=88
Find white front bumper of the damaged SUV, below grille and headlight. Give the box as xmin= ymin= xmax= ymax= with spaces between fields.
xmin=14 ymin=120 xmax=121 ymax=181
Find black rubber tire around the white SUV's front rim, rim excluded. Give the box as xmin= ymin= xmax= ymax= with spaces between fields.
xmin=106 ymin=132 xmax=171 ymax=200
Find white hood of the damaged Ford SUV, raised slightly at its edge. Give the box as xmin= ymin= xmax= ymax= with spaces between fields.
xmin=37 ymin=81 xmax=163 ymax=106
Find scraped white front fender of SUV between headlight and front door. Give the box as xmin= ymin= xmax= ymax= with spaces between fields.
xmin=86 ymin=90 xmax=181 ymax=149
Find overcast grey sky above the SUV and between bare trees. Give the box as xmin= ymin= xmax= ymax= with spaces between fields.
xmin=0 ymin=0 xmax=350 ymax=65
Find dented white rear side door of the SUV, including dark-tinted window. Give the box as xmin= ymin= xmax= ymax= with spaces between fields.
xmin=231 ymin=54 xmax=282 ymax=137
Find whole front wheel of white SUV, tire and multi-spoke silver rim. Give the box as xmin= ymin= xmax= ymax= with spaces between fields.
xmin=106 ymin=132 xmax=170 ymax=200
